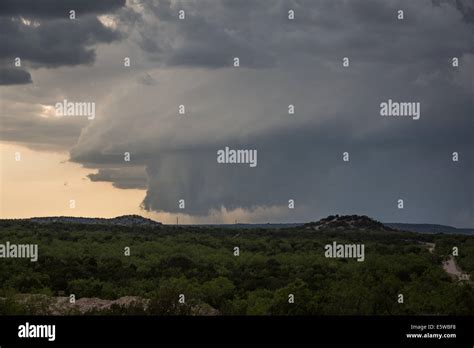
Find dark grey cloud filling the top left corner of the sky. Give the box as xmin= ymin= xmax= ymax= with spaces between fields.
xmin=0 ymin=0 xmax=125 ymax=84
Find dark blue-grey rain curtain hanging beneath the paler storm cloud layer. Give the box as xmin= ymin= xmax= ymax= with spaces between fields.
xmin=137 ymin=92 xmax=474 ymax=216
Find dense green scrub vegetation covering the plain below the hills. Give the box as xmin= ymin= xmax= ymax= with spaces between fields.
xmin=0 ymin=221 xmax=474 ymax=315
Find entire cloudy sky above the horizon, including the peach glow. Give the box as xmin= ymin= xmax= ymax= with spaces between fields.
xmin=0 ymin=0 xmax=474 ymax=227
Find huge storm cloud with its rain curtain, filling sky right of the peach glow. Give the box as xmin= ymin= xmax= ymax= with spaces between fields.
xmin=1 ymin=0 xmax=474 ymax=225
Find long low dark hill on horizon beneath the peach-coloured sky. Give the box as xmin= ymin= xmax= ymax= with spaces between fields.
xmin=20 ymin=215 xmax=162 ymax=227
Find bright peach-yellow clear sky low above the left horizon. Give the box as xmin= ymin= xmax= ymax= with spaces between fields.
xmin=0 ymin=143 xmax=145 ymax=218
